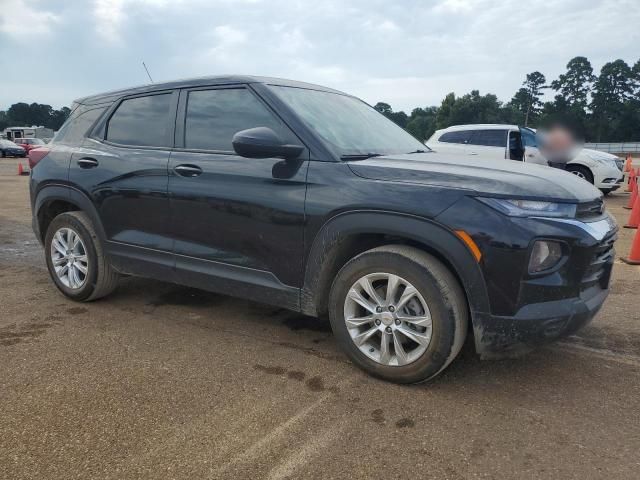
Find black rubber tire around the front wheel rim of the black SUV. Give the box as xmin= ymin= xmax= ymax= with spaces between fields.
xmin=329 ymin=245 xmax=469 ymax=383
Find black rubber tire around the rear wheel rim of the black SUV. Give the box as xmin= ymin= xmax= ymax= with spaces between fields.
xmin=44 ymin=212 xmax=119 ymax=302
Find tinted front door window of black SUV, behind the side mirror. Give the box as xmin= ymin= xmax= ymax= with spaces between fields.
xmin=184 ymin=88 xmax=283 ymax=151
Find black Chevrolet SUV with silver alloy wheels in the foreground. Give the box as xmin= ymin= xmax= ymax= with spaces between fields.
xmin=31 ymin=76 xmax=617 ymax=383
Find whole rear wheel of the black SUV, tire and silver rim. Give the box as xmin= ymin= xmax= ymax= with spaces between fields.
xmin=45 ymin=212 xmax=118 ymax=301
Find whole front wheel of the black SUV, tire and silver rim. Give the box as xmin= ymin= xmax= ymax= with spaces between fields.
xmin=329 ymin=245 xmax=468 ymax=383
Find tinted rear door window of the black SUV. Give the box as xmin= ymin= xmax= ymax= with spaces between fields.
xmin=107 ymin=93 xmax=171 ymax=147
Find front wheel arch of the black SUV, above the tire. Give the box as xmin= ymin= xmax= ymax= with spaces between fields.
xmin=300 ymin=211 xmax=489 ymax=322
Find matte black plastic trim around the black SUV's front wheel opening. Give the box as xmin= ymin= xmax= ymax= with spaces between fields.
xmin=301 ymin=211 xmax=489 ymax=324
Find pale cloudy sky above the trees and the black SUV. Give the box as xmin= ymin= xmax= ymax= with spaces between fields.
xmin=0 ymin=0 xmax=640 ymax=111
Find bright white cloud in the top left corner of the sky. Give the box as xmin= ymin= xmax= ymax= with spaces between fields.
xmin=0 ymin=0 xmax=60 ymax=41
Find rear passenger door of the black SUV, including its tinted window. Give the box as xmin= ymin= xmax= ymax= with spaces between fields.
xmin=69 ymin=91 xmax=178 ymax=274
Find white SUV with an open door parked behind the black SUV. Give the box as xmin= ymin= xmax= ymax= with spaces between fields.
xmin=425 ymin=124 xmax=624 ymax=194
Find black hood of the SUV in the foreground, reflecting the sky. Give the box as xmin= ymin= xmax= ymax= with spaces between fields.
xmin=347 ymin=152 xmax=602 ymax=202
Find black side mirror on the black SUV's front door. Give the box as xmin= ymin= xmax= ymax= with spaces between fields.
xmin=231 ymin=127 xmax=304 ymax=160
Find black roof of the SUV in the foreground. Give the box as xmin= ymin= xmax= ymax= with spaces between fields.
xmin=75 ymin=75 xmax=344 ymax=105
